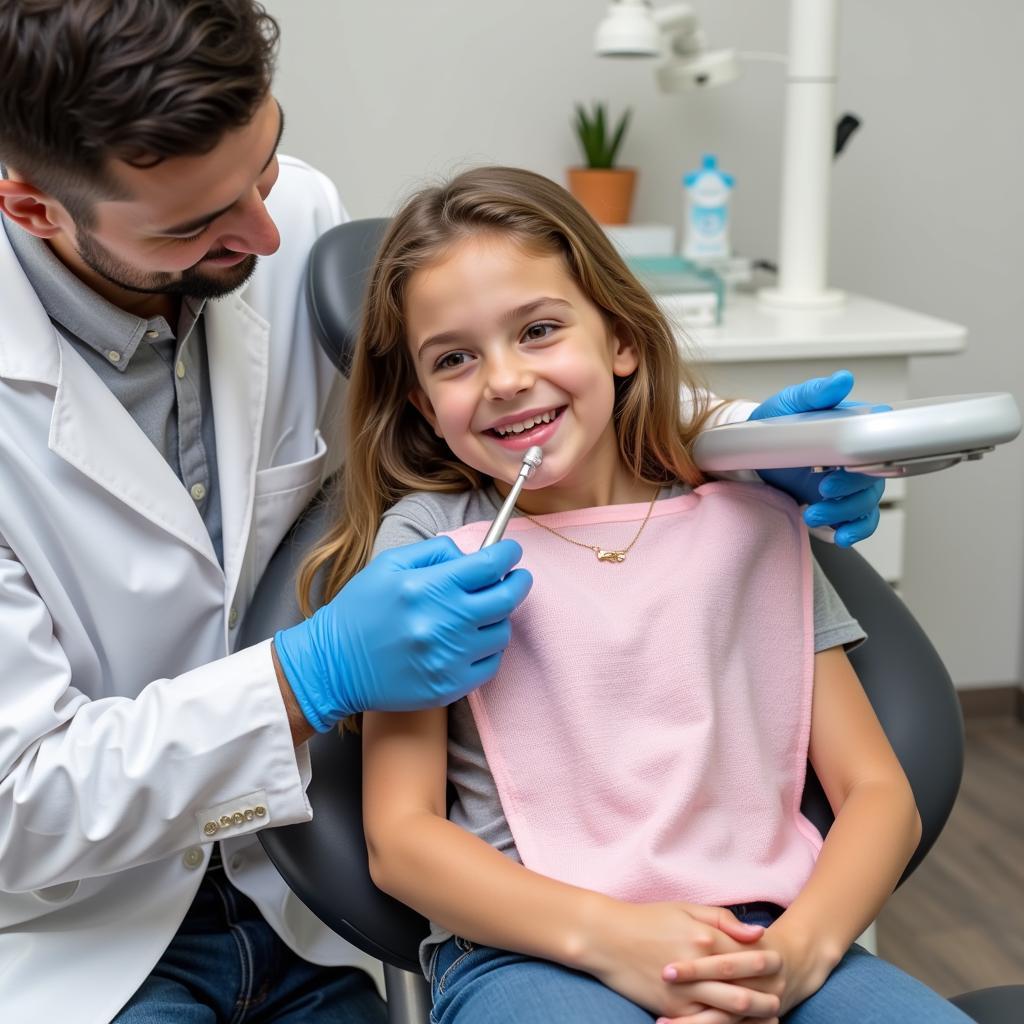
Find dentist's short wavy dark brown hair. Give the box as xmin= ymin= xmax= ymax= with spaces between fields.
xmin=0 ymin=0 xmax=279 ymax=226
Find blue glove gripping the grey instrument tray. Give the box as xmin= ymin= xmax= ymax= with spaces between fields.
xmin=750 ymin=370 xmax=885 ymax=548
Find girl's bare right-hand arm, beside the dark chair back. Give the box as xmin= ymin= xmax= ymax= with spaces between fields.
xmin=663 ymin=647 xmax=921 ymax=1020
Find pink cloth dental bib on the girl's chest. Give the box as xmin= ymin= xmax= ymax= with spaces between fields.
xmin=451 ymin=482 xmax=821 ymax=906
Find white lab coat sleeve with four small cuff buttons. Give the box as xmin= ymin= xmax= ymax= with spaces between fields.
xmin=0 ymin=539 xmax=311 ymax=892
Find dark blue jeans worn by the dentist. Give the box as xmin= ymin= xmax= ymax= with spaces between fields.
xmin=113 ymin=860 xmax=387 ymax=1024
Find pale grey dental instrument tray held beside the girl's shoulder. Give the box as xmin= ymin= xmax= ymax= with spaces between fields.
xmin=693 ymin=392 xmax=1021 ymax=476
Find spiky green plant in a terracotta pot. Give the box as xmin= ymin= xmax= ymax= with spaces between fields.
xmin=569 ymin=103 xmax=637 ymax=224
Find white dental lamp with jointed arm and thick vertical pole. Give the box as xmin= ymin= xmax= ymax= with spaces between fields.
xmin=594 ymin=0 xmax=844 ymax=309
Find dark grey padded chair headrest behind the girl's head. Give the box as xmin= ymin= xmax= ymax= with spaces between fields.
xmin=306 ymin=217 xmax=390 ymax=377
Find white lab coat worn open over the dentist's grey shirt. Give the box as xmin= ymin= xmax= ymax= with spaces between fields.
xmin=0 ymin=158 xmax=382 ymax=1024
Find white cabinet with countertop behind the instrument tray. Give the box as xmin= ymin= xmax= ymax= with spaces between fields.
xmin=658 ymin=292 xmax=967 ymax=585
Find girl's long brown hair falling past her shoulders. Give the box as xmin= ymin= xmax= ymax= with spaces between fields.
xmin=298 ymin=167 xmax=709 ymax=614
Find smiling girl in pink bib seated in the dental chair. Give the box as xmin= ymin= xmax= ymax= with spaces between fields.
xmin=305 ymin=168 xmax=967 ymax=1024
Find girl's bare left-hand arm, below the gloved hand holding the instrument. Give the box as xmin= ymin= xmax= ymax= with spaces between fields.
xmin=362 ymin=709 xmax=779 ymax=1022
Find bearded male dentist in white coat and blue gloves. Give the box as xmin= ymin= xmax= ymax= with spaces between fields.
xmin=0 ymin=0 xmax=879 ymax=1024
